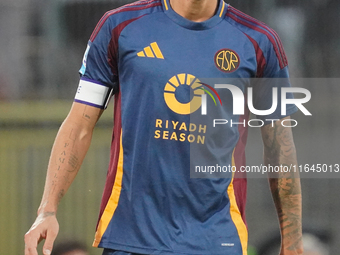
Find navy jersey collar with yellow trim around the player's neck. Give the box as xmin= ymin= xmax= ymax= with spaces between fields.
xmin=161 ymin=0 xmax=228 ymax=30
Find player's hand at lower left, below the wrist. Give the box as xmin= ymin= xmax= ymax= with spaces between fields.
xmin=25 ymin=212 xmax=59 ymax=255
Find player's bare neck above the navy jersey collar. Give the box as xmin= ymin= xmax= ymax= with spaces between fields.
xmin=169 ymin=0 xmax=218 ymax=22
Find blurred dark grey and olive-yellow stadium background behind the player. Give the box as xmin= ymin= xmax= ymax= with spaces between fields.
xmin=0 ymin=0 xmax=340 ymax=255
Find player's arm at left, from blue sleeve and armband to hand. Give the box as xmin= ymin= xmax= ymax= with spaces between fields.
xmin=25 ymin=7 xmax=119 ymax=255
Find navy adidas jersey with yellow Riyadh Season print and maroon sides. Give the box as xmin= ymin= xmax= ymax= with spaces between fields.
xmin=80 ymin=0 xmax=296 ymax=255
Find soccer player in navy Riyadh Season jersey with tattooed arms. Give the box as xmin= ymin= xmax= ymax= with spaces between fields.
xmin=25 ymin=0 xmax=302 ymax=255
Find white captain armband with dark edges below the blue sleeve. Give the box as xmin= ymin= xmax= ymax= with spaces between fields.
xmin=74 ymin=77 xmax=113 ymax=109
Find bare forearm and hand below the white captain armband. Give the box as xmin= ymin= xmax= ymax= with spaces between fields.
xmin=25 ymin=103 xmax=103 ymax=255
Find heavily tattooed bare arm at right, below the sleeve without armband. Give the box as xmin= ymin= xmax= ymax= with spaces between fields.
xmin=261 ymin=117 xmax=303 ymax=255
